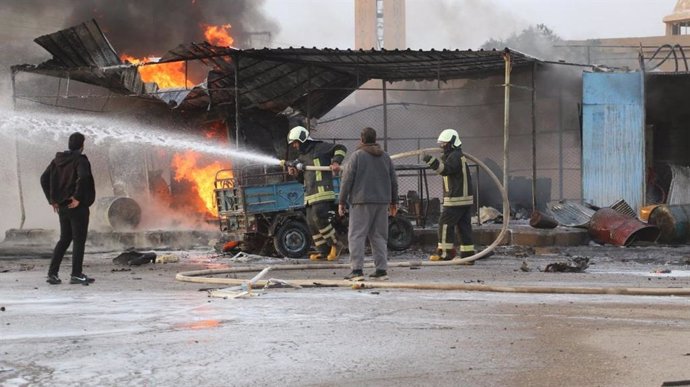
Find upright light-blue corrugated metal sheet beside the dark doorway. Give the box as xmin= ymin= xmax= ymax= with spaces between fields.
xmin=582 ymin=73 xmax=645 ymax=212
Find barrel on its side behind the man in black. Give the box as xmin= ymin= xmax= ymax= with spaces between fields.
xmin=94 ymin=196 xmax=141 ymax=231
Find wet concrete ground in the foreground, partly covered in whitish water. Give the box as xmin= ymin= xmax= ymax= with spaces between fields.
xmin=0 ymin=246 xmax=690 ymax=386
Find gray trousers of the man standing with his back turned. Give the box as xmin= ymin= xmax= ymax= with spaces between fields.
xmin=347 ymin=204 xmax=388 ymax=270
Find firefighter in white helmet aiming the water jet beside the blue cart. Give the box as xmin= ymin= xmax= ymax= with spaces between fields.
xmin=287 ymin=126 xmax=347 ymax=261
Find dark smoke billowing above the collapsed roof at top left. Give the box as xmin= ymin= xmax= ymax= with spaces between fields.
xmin=0 ymin=0 xmax=279 ymax=56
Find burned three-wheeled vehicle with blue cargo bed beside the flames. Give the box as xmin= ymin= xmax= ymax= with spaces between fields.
xmin=214 ymin=167 xmax=414 ymax=258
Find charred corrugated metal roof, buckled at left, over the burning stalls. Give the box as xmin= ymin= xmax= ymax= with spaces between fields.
xmin=14 ymin=20 xmax=538 ymax=118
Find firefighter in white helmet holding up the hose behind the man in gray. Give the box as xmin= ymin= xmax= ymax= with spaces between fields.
xmin=422 ymin=129 xmax=474 ymax=261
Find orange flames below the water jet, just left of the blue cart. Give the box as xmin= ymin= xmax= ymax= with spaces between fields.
xmin=172 ymin=151 xmax=229 ymax=216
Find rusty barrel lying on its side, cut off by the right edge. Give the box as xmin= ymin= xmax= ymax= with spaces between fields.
xmin=648 ymin=204 xmax=690 ymax=244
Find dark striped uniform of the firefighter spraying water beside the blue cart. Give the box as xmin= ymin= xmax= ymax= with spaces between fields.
xmin=297 ymin=140 xmax=347 ymax=259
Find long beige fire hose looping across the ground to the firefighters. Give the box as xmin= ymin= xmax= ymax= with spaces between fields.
xmin=175 ymin=148 xmax=690 ymax=296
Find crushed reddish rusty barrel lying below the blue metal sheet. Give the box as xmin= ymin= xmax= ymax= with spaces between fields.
xmin=588 ymin=207 xmax=659 ymax=246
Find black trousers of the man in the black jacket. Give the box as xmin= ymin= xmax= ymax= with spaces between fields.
xmin=48 ymin=206 xmax=90 ymax=276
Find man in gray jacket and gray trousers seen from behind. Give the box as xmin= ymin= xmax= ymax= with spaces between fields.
xmin=338 ymin=128 xmax=398 ymax=281
